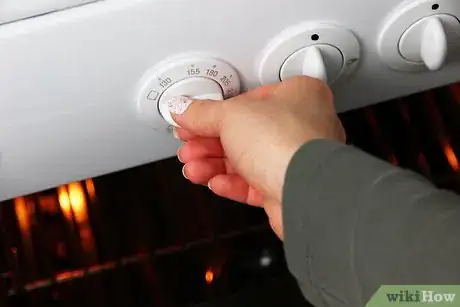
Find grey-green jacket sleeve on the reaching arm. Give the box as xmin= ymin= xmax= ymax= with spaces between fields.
xmin=283 ymin=140 xmax=460 ymax=307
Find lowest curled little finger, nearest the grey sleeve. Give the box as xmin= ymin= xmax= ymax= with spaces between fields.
xmin=208 ymin=174 xmax=264 ymax=207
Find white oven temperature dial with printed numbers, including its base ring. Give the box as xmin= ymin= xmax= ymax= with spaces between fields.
xmin=137 ymin=54 xmax=241 ymax=131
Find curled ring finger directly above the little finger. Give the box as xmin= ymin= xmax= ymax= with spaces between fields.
xmin=182 ymin=158 xmax=230 ymax=184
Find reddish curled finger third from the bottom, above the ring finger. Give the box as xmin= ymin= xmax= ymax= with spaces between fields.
xmin=177 ymin=138 xmax=225 ymax=164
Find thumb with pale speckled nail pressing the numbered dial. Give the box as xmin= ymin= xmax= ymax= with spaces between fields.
xmin=168 ymin=96 xmax=224 ymax=137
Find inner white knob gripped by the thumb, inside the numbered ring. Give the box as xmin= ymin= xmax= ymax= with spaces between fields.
xmin=158 ymin=77 xmax=224 ymax=127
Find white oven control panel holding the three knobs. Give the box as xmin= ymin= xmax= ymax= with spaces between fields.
xmin=0 ymin=0 xmax=460 ymax=200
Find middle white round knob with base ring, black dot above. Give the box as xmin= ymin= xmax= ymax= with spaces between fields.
xmin=256 ymin=22 xmax=361 ymax=88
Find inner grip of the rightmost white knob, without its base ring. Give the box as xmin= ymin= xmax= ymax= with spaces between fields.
xmin=399 ymin=14 xmax=460 ymax=71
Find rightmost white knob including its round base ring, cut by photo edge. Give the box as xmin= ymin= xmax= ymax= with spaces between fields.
xmin=377 ymin=0 xmax=460 ymax=72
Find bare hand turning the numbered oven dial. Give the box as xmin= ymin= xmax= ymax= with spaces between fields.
xmin=169 ymin=77 xmax=345 ymax=239
